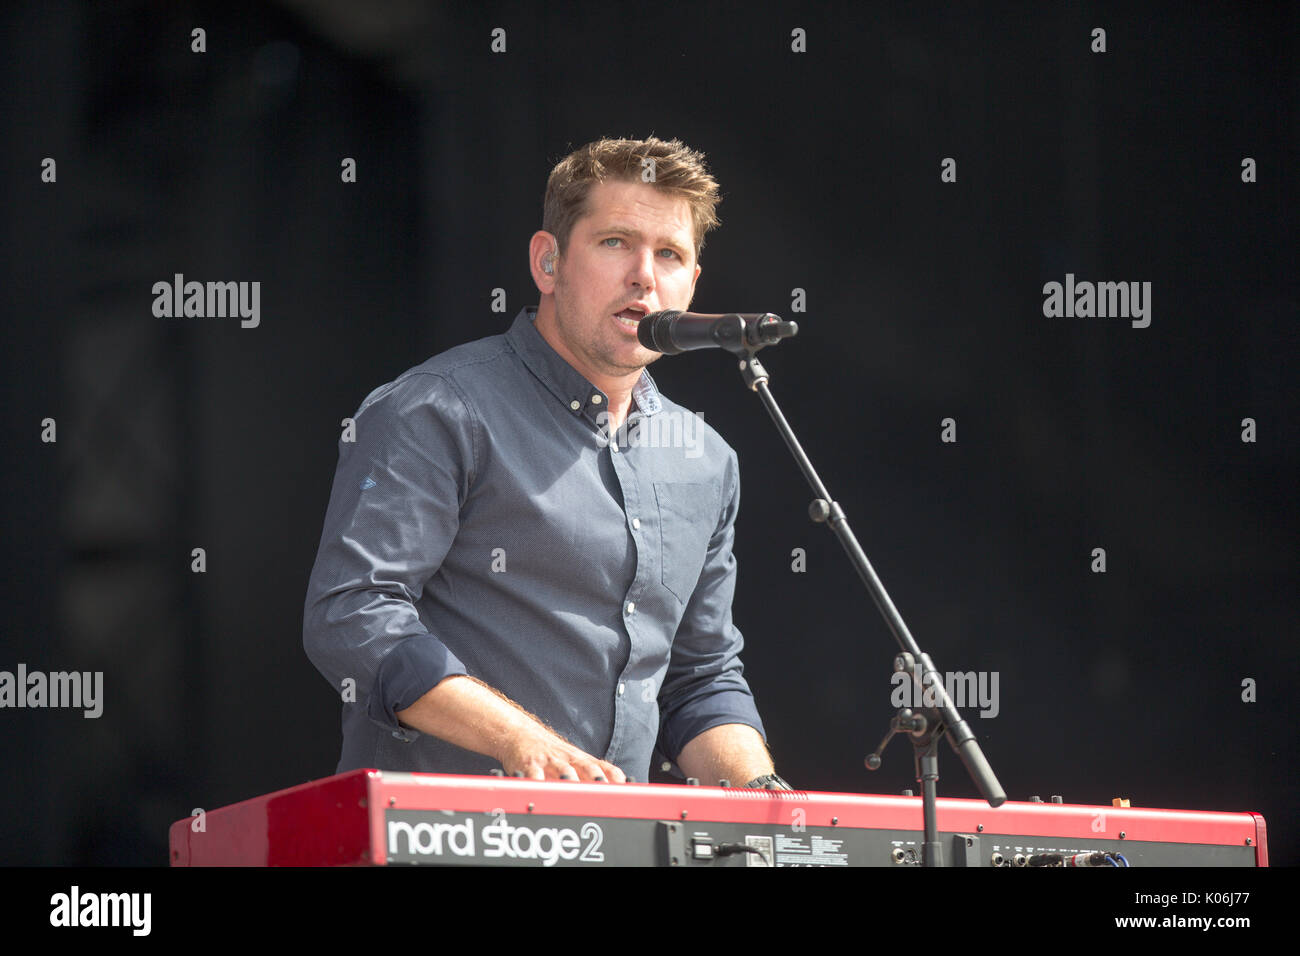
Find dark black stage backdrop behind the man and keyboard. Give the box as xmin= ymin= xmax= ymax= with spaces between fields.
xmin=0 ymin=0 xmax=1300 ymax=865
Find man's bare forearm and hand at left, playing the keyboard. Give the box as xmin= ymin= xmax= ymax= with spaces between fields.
xmin=395 ymin=675 xmax=627 ymax=783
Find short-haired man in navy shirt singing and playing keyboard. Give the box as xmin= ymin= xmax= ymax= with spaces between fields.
xmin=303 ymin=138 xmax=785 ymax=787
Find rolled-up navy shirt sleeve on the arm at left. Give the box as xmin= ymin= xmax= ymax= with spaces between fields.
xmin=303 ymin=372 xmax=481 ymax=739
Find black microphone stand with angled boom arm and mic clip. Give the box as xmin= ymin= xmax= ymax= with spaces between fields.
xmin=718 ymin=316 xmax=1006 ymax=866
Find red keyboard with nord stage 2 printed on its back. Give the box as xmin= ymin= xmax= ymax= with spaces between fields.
xmin=170 ymin=770 xmax=1269 ymax=868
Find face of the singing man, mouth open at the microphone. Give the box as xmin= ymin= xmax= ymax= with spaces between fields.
xmin=540 ymin=182 xmax=699 ymax=380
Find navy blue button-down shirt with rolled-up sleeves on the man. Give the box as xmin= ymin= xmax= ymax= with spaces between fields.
xmin=303 ymin=308 xmax=763 ymax=780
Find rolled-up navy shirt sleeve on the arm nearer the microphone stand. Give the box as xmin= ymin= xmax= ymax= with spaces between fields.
xmin=658 ymin=450 xmax=767 ymax=761
